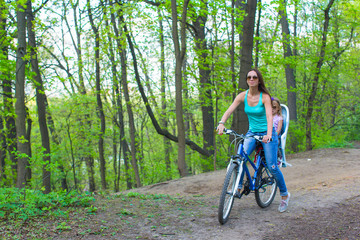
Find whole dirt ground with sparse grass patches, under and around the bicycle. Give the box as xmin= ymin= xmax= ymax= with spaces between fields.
xmin=0 ymin=149 xmax=360 ymax=240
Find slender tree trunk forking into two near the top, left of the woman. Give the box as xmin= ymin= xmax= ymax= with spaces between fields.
xmin=171 ymin=0 xmax=189 ymax=177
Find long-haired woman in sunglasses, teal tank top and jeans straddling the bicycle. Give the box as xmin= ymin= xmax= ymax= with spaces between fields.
xmin=217 ymin=69 xmax=290 ymax=212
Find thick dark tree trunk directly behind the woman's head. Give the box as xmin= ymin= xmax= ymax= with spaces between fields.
xmin=232 ymin=0 xmax=257 ymax=133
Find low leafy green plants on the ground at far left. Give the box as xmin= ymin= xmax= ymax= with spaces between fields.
xmin=0 ymin=188 xmax=96 ymax=220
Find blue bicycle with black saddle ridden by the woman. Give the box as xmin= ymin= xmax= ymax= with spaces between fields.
xmin=218 ymin=129 xmax=277 ymax=224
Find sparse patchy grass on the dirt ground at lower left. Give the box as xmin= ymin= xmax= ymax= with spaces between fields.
xmin=0 ymin=192 xmax=212 ymax=239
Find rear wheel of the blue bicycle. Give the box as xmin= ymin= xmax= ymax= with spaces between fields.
xmin=255 ymin=159 xmax=277 ymax=208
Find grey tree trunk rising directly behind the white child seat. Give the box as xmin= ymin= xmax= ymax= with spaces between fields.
xmin=279 ymin=0 xmax=297 ymax=121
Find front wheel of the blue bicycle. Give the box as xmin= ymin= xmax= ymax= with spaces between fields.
xmin=218 ymin=163 xmax=239 ymax=224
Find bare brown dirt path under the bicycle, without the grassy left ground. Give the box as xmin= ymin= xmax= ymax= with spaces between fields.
xmin=124 ymin=149 xmax=360 ymax=239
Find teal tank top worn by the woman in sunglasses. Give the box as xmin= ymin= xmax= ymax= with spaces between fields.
xmin=244 ymin=90 xmax=267 ymax=132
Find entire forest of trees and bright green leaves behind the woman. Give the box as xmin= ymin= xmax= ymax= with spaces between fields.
xmin=0 ymin=0 xmax=360 ymax=194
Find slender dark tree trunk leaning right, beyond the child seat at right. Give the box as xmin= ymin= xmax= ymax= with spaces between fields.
xmin=305 ymin=0 xmax=335 ymax=150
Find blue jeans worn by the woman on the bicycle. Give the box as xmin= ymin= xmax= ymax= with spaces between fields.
xmin=244 ymin=129 xmax=288 ymax=196
